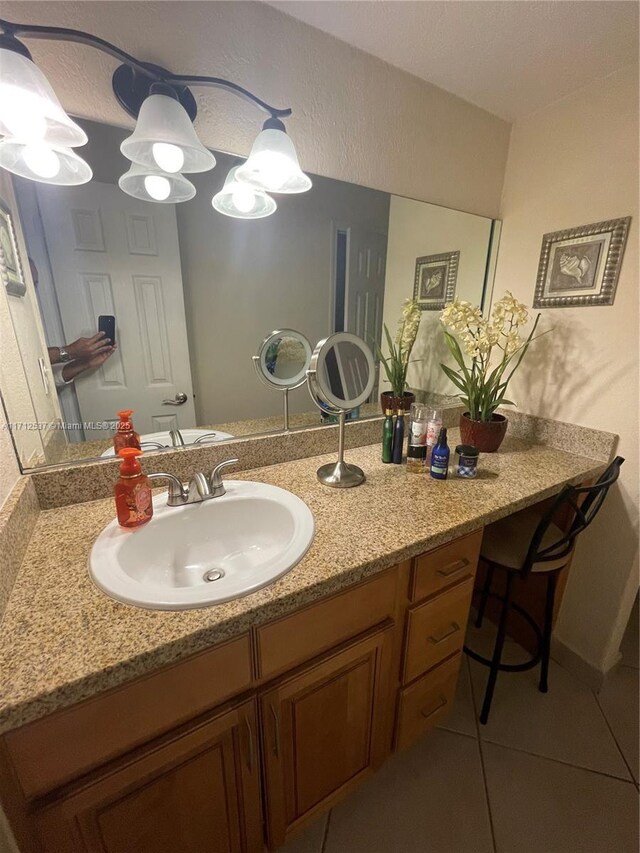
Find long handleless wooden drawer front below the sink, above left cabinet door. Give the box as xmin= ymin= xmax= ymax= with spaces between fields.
xmin=5 ymin=634 xmax=252 ymax=799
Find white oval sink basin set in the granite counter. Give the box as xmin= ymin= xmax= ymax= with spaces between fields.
xmin=89 ymin=480 xmax=314 ymax=610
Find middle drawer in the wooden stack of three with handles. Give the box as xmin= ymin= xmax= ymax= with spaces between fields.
xmin=403 ymin=578 xmax=473 ymax=684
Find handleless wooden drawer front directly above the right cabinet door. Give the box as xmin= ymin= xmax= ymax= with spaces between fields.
xmin=256 ymin=567 xmax=398 ymax=678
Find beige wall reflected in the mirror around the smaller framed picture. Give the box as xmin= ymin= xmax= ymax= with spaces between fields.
xmin=381 ymin=196 xmax=491 ymax=394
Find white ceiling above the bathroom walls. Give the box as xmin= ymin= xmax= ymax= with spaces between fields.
xmin=270 ymin=0 xmax=639 ymax=121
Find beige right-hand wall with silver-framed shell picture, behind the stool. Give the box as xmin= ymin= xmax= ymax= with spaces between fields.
xmin=495 ymin=67 xmax=639 ymax=671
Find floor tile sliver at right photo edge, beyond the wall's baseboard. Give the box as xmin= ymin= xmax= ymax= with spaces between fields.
xmin=598 ymin=658 xmax=640 ymax=782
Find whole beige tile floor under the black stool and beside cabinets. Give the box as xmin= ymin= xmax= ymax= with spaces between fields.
xmin=281 ymin=600 xmax=639 ymax=853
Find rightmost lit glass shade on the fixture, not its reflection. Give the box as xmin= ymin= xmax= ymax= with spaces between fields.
xmin=237 ymin=128 xmax=311 ymax=193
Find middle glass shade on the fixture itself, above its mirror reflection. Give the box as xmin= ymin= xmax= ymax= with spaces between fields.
xmin=120 ymin=95 xmax=216 ymax=173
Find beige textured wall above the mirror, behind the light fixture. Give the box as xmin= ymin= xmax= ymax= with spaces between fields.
xmin=0 ymin=0 xmax=509 ymax=500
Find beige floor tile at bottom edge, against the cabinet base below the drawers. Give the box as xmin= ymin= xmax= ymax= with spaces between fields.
xmin=325 ymin=729 xmax=493 ymax=853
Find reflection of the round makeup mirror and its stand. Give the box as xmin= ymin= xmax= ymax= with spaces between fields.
xmin=253 ymin=329 xmax=311 ymax=432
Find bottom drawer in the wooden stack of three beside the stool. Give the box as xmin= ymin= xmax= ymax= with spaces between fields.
xmin=396 ymin=654 xmax=462 ymax=749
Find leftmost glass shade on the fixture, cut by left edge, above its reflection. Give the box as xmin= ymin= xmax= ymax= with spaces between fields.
xmin=0 ymin=48 xmax=87 ymax=148
